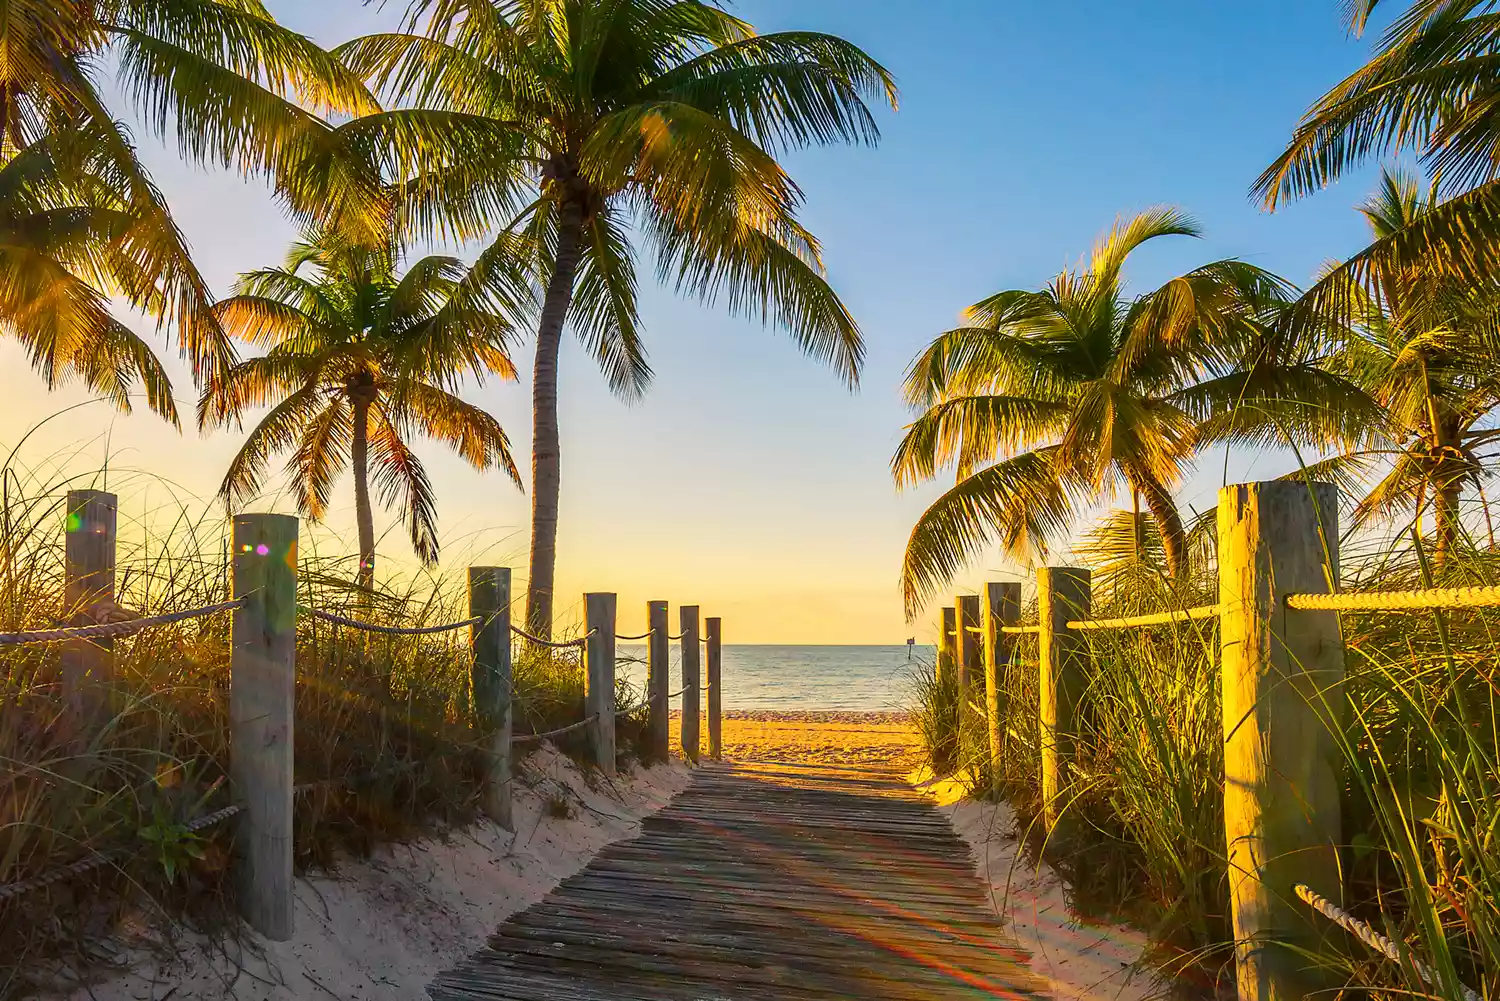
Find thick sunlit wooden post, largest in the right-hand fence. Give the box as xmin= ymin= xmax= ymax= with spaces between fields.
xmin=1218 ymin=480 xmax=1344 ymax=1001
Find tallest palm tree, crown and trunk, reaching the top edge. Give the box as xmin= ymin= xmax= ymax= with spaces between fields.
xmin=338 ymin=0 xmax=896 ymax=635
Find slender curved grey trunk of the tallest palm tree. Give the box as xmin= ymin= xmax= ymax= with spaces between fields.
xmin=527 ymin=197 xmax=584 ymax=639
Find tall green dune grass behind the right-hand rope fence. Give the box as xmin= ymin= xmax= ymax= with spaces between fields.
xmin=917 ymin=534 xmax=1500 ymax=999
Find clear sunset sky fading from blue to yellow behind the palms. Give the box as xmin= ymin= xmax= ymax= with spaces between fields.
xmin=0 ymin=0 xmax=1373 ymax=644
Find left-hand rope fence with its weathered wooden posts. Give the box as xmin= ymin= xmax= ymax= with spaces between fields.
xmin=0 ymin=491 xmax=720 ymax=941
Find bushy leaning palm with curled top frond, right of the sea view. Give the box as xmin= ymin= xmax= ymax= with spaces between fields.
xmin=891 ymin=209 xmax=1335 ymax=615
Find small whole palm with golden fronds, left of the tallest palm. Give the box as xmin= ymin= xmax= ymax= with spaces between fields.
xmin=198 ymin=233 xmax=521 ymax=588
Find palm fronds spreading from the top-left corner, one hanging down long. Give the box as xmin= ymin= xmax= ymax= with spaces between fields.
xmin=0 ymin=0 xmax=378 ymax=375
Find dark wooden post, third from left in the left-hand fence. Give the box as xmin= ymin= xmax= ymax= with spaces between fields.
xmin=470 ymin=567 xmax=516 ymax=831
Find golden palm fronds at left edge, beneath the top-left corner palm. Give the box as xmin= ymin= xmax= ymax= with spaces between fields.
xmin=0 ymin=125 xmax=177 ymax=425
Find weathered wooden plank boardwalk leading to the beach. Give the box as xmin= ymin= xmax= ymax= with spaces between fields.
xmin=429 ymin=764 xmax=1044 ymax=1001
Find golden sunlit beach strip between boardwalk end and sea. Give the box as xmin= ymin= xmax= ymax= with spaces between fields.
xmin=672 ymin=710 xmax=918 ymax=771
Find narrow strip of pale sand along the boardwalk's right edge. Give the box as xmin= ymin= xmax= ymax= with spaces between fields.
xmin=911 ymin=771 xmax=1172 ymax=1001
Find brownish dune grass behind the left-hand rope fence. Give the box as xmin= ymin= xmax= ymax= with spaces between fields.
xmin=0 ymin=470 xmax=644 ymax=999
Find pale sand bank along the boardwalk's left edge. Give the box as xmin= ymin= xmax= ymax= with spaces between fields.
xmin=61 ymin=744 xmax=689 ymax=1001
